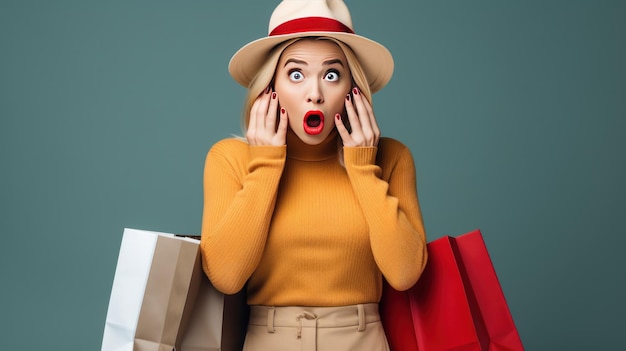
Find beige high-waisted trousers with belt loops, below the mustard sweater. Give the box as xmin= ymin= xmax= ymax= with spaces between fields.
xmin=243 ymin=303 xmax=389 ymax=351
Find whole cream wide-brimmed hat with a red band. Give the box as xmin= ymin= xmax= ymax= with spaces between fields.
xmin=228 ymin=0 xmax=393 ymax=92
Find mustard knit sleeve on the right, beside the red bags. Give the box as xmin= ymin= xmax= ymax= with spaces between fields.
xmin=344 ymin=139 xmax=427 ymax=290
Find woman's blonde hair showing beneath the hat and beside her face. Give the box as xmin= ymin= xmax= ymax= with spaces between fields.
xmin=241 ymin=37 xmax=372 ymax=135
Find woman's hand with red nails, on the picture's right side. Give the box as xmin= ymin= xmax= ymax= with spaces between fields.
xmin=335 ymin=88 xmax=380 ymax=147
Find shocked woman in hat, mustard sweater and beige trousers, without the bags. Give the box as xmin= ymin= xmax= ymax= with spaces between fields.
xmin=201 ymin=0 xmax=427 ymax=350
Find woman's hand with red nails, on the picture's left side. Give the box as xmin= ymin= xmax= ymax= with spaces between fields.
xmin=246 ymin=87 xmax=287 ymax=146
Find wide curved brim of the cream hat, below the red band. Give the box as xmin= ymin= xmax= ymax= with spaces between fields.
xmin=228 ymin=32 xmax=394 ymax=93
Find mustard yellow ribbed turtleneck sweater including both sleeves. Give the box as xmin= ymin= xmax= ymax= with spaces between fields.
xmin=201 ymin=131 xmax=427 ymax=306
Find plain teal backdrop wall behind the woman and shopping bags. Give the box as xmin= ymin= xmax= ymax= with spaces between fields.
xmin=0 ymin=0 xmax=626 ymax=350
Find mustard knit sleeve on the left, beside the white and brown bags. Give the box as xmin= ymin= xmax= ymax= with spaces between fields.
xmin=200 ymin=139 xmax=286 ymax=294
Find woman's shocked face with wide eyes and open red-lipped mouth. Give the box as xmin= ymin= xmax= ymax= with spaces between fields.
xmin=274 ymin=39 xmax=352 ymax=145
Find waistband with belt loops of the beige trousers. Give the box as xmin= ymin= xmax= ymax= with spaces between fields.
xmin=249 ymin=303 xmax=380 ymax=332
